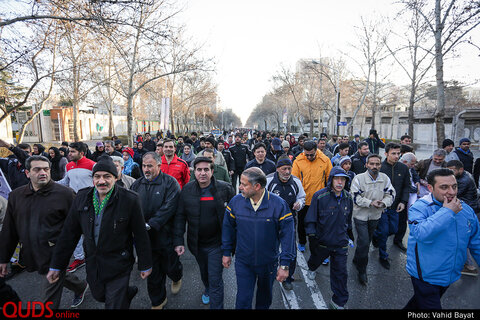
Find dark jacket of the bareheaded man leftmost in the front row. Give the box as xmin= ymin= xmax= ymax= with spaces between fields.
xmin=0 ymin=181 xmax=75 ymax=274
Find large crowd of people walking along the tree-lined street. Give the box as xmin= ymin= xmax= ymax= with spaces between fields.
xmin=0 ymin=129 xmax=480 ymax=309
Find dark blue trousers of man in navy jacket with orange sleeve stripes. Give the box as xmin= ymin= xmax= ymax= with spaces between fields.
xmin=235 ymin=259 xmax=277 ymax=309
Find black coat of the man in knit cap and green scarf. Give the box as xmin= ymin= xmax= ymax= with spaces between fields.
xmin=50 ymin=186 xmax=152 ymax=283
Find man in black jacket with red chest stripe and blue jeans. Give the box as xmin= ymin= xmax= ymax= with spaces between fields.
xmin=173 ymin=157 xmax=235 ymax=309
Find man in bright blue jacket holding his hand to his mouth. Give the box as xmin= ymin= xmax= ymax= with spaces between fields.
xmin=405 ymin=168 xmax=480 ymax=309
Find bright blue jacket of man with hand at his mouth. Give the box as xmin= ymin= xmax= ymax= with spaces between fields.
xmin=407 ymin=195 xmax=480 ymax=287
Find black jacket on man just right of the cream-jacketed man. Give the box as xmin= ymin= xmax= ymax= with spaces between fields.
xmin=380 ymin=160 xmax=411 ymax=210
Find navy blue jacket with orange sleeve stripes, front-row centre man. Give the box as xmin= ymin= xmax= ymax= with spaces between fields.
xmin=222 ymin=190 xmax=296 ymax=266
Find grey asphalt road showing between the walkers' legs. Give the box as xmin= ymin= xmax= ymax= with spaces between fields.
xmin=7 ymin=231 xmax=480 ymax=310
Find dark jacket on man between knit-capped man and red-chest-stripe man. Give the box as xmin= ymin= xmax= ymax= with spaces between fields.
xmin=130 ymin=172 xmax=180 ymax=250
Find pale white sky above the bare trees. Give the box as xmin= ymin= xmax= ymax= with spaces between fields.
xmin=177 ymin=0 xmax=480 ymax=124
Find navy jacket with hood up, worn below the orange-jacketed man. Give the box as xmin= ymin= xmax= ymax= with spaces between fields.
xmin=304 ymin=167 xmax=353 ymax=248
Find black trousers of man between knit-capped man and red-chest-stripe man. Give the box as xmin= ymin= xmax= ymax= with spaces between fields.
xmin=147 ymin=248 xmax=183 ymax=307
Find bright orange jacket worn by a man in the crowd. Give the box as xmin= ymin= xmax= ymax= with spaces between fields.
xmin=292 ymin=150 xmax=332 ymax=206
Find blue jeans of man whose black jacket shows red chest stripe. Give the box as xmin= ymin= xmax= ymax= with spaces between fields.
xmin=195 ymin=246 xmax=223 ymax=309
